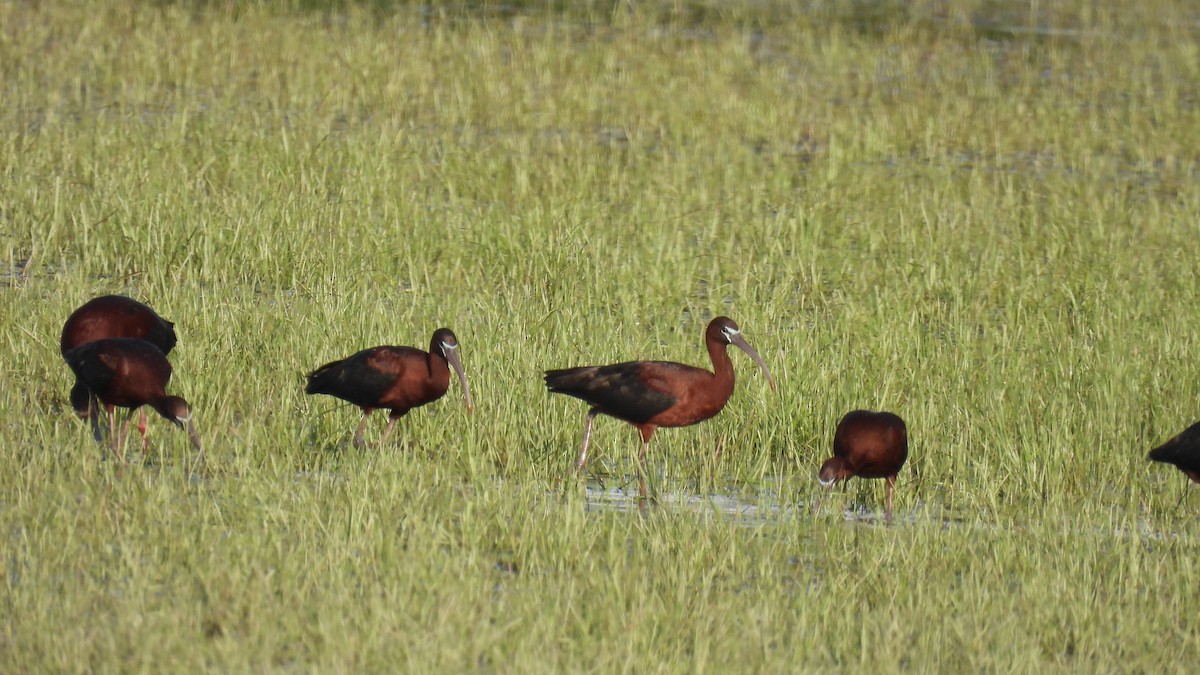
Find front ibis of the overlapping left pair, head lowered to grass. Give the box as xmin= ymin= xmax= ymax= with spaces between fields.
xmin=64 ymin=338 xmax=204 ymax=461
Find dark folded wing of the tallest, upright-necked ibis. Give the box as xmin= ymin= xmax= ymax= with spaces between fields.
xmin=546 ymin=362 xmax=676 ymax=424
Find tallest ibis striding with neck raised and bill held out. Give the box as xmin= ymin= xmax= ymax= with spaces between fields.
xmin=546 ymin=316 xmax=775 ymax=498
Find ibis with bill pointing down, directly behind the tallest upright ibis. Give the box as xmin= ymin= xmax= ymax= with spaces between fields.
xmin=305 ymin=328 xmax=472 ymax=447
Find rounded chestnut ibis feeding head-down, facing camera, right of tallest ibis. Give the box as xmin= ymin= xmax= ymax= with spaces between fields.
xmin=817 ymin=410 xmax=908 ymax=520
